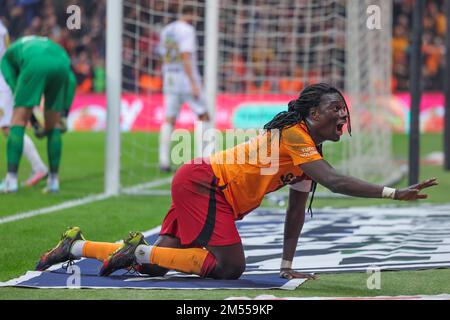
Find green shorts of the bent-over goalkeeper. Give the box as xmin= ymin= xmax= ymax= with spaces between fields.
xmin=14 ymin=57 xmax=70 ymax=112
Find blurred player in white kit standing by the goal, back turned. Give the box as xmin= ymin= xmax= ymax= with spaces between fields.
xmin=159 ymin=5 xmax=209 ymax=172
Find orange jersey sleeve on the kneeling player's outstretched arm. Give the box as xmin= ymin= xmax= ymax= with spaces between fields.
xmin=281 ymin=125 xmax=322 ymax=165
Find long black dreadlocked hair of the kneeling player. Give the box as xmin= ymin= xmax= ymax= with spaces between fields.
xmin=264 ymin=83 xmax=352 ymax=217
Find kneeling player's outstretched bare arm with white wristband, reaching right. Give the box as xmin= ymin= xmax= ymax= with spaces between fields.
xmin=300 ymin=160 xmax=438 ymax=201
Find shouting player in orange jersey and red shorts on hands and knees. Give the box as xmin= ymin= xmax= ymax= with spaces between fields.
xmin=36 ymin=84 xmax=437 ymax=279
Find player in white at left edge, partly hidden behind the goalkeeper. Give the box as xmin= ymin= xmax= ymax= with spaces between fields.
xmin=0 ymin=20 xmax=48 ymax=192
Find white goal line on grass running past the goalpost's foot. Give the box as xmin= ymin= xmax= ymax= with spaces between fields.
xmin=0 ymin=178 xmax=172 ymax=225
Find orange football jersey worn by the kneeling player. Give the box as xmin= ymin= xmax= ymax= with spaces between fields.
xmin=210 ymin=122 xmax=322 ymax=219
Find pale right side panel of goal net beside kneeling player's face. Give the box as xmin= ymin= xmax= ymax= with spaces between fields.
xmin=341 ymin=0 xmax=401 ymax=181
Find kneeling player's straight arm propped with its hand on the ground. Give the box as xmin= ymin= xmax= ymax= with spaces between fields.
xmin=280 ymin=189 xmax=316 ymax=279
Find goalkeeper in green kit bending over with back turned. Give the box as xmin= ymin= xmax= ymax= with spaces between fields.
xmin=0 ymin=36 xmax=70 ymax=193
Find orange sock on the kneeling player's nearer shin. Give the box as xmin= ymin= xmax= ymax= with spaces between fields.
xmin=150 ymin=246 xmax=216 ymax=277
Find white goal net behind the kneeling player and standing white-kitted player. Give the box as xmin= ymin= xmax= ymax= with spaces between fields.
xmin=113 ymin=0 xmax=399 ymax=193
